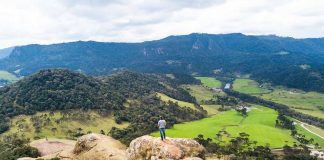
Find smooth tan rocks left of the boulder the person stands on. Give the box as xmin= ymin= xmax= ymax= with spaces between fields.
xmin=19 ymin=134 xmax=127 ymax=160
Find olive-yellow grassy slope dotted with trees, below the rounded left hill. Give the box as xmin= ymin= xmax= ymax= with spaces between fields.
xmin=2 ymin=112 xmax=128 ymax=139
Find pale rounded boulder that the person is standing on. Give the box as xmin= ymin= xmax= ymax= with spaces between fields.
xmin=126 ymin=136 xmax=205 ymax=160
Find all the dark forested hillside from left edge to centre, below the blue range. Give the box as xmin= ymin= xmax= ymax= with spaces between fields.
xmin=0 ymin=69 xmax=206 ymax=143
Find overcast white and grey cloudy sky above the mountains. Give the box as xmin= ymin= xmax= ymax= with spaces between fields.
xmin=0 ymin=0 xmax=324 ymax=48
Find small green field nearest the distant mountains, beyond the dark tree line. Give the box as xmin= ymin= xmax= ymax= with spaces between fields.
xmin=233 ymin=79 xmax=271 ymax=94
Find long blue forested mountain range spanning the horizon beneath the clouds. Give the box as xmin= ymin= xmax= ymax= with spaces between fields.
xmin=0 ymin=33 xmax=324 ymax=92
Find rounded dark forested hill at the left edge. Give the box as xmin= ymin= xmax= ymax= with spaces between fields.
xmin=0 ymin=69 xmax=125 ymax=115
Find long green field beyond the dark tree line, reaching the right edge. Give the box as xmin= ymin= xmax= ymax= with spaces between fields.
xmin=259 ymin=87 xmax=324 ymax=118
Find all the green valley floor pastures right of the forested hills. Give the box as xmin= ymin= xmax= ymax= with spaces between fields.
xmin=152 ymin=77 xmax=324 ymax=148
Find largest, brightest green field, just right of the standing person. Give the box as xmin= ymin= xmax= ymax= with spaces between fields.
xmin=152 ymin=106 xmax=295 ymax=148
